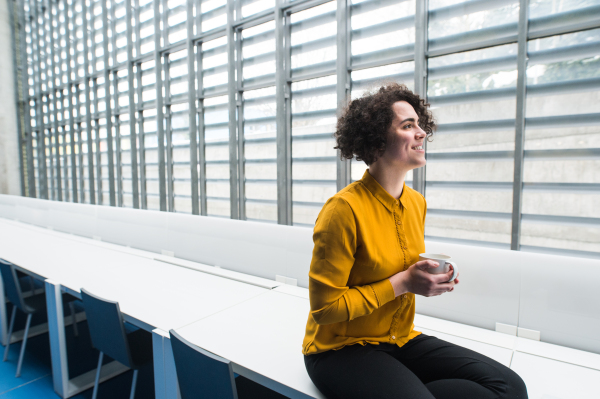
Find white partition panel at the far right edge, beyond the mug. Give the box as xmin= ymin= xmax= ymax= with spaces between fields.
xmin=517 ymin=252 xmax=600 ymax=353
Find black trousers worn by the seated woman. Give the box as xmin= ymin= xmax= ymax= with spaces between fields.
xmin=304 ymin=334 xmax=527 ymax=399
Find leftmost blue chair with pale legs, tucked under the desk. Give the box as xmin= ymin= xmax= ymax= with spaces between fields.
xmin=0 ymin=259 xmax=77 ymax=377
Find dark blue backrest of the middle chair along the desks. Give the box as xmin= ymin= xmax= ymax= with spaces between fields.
xmin=81 ymin=288 xmax=134 ymax=367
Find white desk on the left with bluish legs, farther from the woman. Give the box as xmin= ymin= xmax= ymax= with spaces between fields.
xmin=0 ymin=225 xmax=268 ymax=398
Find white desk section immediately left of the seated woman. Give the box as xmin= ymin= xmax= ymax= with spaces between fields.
xmin=176 ymin=290 xmax=324 ymax=398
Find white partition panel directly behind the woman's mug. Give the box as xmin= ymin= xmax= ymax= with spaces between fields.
xmin=416 ymin=240 xmax=522 ymax=330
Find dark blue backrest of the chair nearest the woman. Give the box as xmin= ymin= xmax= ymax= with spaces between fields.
xmin=169 ymin=330 xmax=237 ymax=399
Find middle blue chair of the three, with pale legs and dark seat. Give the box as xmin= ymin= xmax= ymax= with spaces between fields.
xmin=81 ymin=288 xmax=152 ymax=399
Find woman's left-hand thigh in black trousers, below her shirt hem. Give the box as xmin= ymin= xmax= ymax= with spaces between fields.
xmin=304 ymin=345 xmax=435 ymax=399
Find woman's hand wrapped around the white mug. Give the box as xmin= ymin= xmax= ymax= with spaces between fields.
xmin=389 ymin=259 xmax=459 ymax=297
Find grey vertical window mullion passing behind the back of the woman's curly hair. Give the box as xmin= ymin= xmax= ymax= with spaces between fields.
xmin=336 ymin=0 xmax=351 ymax=191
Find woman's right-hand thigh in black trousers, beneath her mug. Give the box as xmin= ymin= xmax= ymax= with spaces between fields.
xmin=394 ymin=335 xmax=527 ymax=398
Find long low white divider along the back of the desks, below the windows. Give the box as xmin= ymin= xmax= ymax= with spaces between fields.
xmin=0 ymin=195 xmax=600 ymax=353
